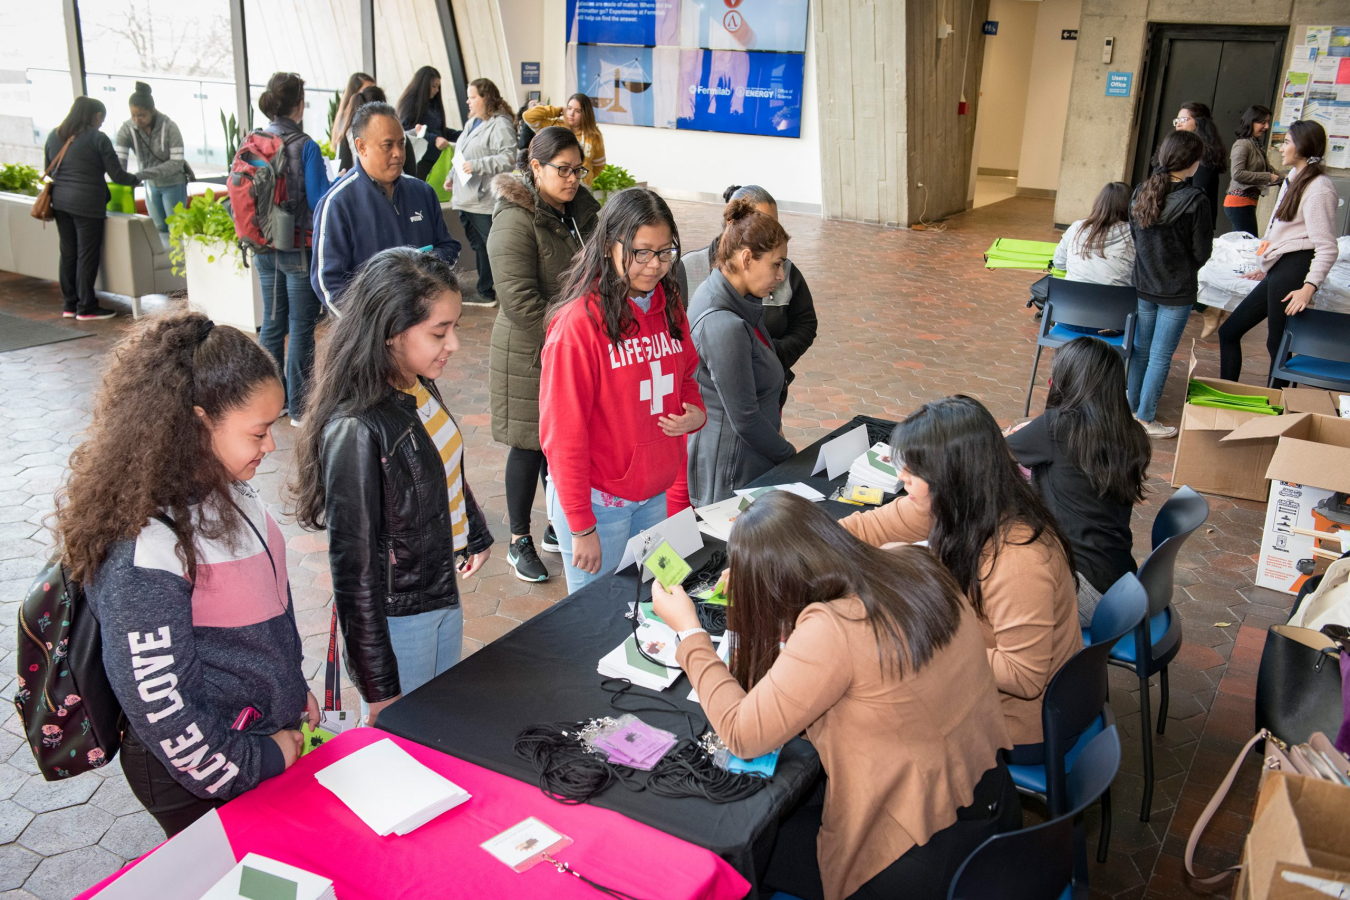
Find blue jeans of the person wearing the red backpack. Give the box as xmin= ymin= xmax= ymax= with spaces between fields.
xmin=254 ymin=250 xmax=323 ymax=420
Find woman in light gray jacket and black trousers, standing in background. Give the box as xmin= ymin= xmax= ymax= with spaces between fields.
xmin=446 ymin=78 xmax=516 ymax=306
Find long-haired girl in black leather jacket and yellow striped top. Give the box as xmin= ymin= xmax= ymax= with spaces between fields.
xmin=294 ymin=247 xmax=493 ymax=725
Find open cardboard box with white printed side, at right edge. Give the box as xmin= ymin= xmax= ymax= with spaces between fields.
xmin=1236 ymin=413 xmax=1350 ymax=594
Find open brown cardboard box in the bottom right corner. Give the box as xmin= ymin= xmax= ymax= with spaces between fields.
xmin=1238 ymin=772 xmax=1350 ymax=900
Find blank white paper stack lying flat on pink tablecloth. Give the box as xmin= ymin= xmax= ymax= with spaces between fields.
xmin=315 ymin=738 xmax=468 ymax=837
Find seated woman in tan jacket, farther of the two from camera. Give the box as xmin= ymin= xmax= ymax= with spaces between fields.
xmin=840 ymin=397 xmax=1083 ymax=765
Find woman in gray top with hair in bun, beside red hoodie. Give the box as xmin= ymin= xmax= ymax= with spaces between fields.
xmin=689 ymin=198 xmax=797 ymax=507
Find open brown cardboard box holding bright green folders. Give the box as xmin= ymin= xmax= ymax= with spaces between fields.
xmin=1172 ymin=367 xmax=1284 ymax=501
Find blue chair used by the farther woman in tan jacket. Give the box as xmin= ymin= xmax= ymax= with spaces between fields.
xmin=1008 ymin=575 xmax=1149 ymax=862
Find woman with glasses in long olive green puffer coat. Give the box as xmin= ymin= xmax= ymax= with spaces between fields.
xmin=487 ymin=127 xmax=599 ymax=582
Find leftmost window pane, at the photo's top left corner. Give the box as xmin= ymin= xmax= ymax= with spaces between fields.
xmin=0 ymin=0 xmax=74 ymax=166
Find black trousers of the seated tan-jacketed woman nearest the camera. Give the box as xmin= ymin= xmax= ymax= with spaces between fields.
xmin=761 ymin=761 xmax=1022 ymax=900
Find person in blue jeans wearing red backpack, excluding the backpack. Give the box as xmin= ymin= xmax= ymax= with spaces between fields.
xmin=255 ymin=72 xmax=329 ymax=428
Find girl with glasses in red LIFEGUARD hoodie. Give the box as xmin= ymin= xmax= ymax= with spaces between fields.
xmin=539 ymin=188 xmax=707 ymax=591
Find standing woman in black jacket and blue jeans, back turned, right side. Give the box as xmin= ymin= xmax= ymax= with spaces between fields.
xmin=1127 ymin=131 xmax=1214 ymax=437
